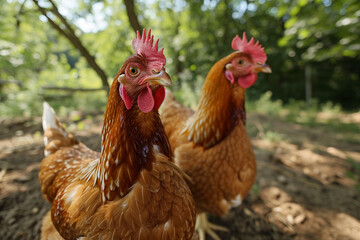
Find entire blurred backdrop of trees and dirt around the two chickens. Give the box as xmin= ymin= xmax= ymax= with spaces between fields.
xmin=0 ymin=0 xmax=360 ymax=240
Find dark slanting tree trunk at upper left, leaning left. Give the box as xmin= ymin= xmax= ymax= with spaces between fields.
xmin=33 ymin=0 xmax=109 ymax=89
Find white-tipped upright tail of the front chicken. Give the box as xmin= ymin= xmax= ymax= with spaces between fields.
xmin=42 ymin=102 xmax=79 ymax=156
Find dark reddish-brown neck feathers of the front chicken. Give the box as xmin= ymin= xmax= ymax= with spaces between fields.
xmin=95 ymin=77 xmax=171 ymax=202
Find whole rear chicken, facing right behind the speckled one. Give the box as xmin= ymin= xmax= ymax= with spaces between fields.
xmin=160 ymin=34 xmax=271 ymax=239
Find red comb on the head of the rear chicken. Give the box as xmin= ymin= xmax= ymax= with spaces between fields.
xmin=231 ymin=32 xmax=267 ymax=63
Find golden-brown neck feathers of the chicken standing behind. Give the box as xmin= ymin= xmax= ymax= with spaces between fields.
xmin=184 ymin=54 xmax=245 ymax=148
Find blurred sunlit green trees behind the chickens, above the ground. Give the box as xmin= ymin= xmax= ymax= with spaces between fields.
xmin=0 ymin=0 xmax=360 ymax=118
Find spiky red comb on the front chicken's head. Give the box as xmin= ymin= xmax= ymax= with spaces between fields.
xmin=133 ymin=29 xmax=166 ymax=68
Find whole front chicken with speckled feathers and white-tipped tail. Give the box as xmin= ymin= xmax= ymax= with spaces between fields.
xmin=39 ymin=29 xmax=195 ymax=240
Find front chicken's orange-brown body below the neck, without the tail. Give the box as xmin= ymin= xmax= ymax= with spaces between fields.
xmin=40 ymin=136 xmax=194 ymax=239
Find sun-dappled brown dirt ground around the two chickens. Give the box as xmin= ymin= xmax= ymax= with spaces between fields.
xmin=0 ymin=114 xmax=360 ymax=240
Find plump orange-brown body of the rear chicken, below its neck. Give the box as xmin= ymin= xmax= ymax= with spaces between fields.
xmin=161 ymin=74 xmax=256 ymax=216
